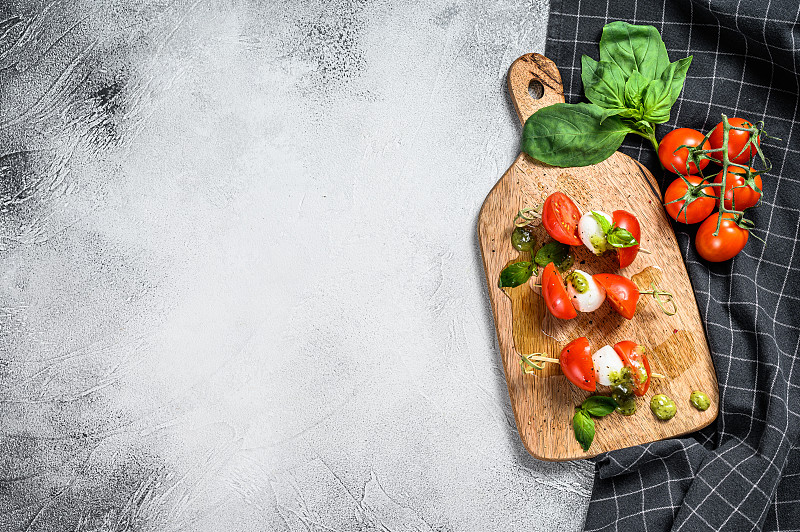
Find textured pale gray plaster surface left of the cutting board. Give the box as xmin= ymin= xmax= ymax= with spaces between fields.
xmin=0 ymin=0 xmax=592 ymax=531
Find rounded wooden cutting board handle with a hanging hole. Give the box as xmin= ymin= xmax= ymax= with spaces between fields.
xmin=508 ymin=54 xmax=564 ymax=124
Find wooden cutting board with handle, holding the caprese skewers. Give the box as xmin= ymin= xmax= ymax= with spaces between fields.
xmin=478 ymin=54 xmax=719 ymax=460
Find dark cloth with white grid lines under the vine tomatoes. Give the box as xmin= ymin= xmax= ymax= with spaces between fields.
xmin=546 ymin=0 xmax=800 ymax=532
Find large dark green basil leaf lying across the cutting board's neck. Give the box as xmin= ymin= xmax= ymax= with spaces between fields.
xmin=522 ymin=103 xmax=632 ymax=167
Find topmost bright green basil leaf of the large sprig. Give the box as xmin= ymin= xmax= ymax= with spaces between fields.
xmin=600 ymin=20 xmax=669 ymax=80
